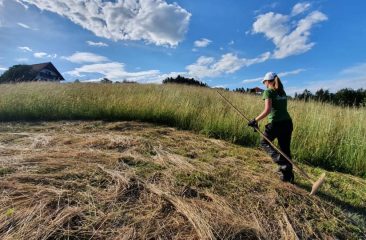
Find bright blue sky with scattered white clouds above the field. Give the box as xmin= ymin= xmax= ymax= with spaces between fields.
xmin=0 ymin=0 xmax=366 ymax=95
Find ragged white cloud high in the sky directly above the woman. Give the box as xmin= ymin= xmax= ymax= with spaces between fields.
xmin=252 ymin=4 xmax=328 ymax=59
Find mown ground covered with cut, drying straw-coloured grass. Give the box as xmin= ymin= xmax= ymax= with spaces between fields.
xmin=0 ymin=121 xmax=366 ymax=239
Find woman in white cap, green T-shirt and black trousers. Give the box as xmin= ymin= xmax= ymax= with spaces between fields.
xmin=248 ymin=72 xmax=294 ymax=183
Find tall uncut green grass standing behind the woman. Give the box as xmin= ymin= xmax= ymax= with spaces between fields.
xmin=0 ymin=83 xmax=366 ymax=177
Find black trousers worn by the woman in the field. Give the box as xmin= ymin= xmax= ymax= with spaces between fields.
xmin=260 ymin=119 xmax=293 ymax=170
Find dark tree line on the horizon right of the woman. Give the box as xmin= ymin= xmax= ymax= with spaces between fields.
xmin=294 ymin=88 xmax=366 ymax=107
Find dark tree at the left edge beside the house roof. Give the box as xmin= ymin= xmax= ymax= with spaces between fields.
xmin=0 ymin=65 xmax=34 ymax=83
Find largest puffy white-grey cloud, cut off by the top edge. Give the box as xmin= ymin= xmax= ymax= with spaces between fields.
xmin=21 ymin=0 xmax=191 ymax=47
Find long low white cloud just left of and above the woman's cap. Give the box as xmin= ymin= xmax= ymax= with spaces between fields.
xmin=186 ymin=52 xmax=270 ymax=78
